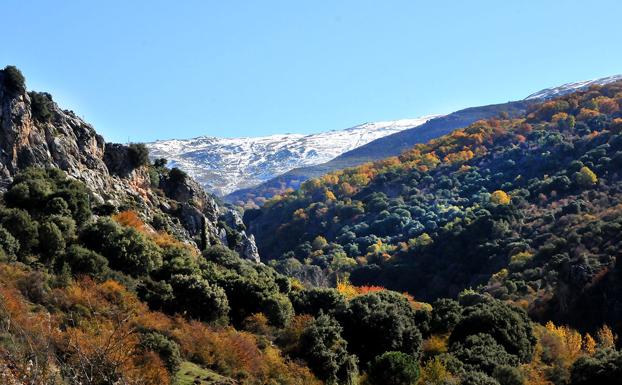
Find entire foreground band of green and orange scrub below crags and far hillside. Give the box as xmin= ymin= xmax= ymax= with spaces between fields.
xmin=0 ymin=169 xmax=618 ymax=385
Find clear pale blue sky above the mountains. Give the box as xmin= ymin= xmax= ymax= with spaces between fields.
xmin=0 ymin=0 xmax=622 ymax=142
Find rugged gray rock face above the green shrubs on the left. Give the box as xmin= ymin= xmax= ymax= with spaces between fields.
xmin=0 ymin=72 xmax=259 ymax=262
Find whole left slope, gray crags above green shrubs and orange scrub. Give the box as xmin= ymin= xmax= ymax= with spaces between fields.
xmin=0 ymin=66 xmax=330 ymax=385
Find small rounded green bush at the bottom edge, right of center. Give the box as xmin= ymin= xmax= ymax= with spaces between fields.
xmin=367 ymin=352 xmax=419 ymax=385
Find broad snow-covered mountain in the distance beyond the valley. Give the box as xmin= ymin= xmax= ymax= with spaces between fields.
xmin=146 ymin=116 xmax=436 ymax=196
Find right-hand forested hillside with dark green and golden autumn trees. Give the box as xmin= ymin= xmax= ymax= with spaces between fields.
xmin=246 ymin=83 xmax=622 ymax=331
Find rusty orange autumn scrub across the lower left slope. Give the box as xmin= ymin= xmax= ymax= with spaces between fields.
xmin=0 ymin=264 xmax=318 ymax=385
